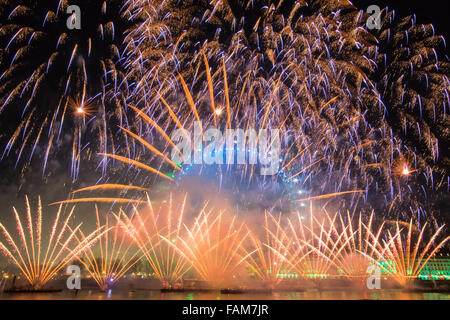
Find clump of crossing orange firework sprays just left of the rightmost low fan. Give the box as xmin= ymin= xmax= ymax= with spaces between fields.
xmin=258 ymin=207 xmax=383 ymax=279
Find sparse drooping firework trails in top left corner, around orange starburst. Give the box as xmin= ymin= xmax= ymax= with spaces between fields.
xmin=0 ymin=0 xmax=137 ymax=178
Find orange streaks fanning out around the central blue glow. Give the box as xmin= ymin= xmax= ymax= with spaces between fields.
xmin=81 ymin=56 xmax=366 ymax=218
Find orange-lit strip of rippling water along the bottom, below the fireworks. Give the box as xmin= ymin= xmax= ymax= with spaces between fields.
xmin=0 ymin=290 xmax=450 ymax=300
